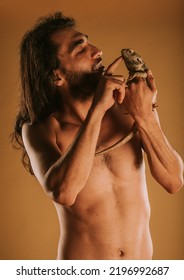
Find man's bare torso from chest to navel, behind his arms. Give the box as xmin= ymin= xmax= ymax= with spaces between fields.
xmin=50 ymin=105 xmax=152 ymax=260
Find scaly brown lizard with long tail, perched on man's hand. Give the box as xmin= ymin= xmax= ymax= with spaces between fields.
xmin=95 ymin=49 xmax=151 ymax=156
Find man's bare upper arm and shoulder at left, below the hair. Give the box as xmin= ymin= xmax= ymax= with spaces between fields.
xmin=22 ymin=124 xmax=62 ymax=186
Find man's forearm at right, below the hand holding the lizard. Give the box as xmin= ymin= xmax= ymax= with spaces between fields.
xmin=136 ymin=113 xmax=183 ymax=193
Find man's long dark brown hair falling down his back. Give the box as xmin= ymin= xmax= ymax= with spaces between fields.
xmin=12 ymin=12 xmax=75 ymax=174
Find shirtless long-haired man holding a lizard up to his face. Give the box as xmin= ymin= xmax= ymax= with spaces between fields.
xmin=14 ymin=13 xmax=183 ymax=260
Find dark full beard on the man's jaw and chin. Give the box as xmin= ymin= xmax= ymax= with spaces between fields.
xmin=65 ymin=70 xmax=101 ymax=101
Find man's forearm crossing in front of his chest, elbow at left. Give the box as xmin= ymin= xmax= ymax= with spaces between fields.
xmin=45 ymin=107 xmax=103 ymax=205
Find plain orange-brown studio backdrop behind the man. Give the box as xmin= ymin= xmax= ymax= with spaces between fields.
xmin=0 ymin=0 xmax=184 ymax=260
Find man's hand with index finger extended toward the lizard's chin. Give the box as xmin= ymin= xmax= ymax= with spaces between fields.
xmin=93 ymin=57 xmax=125 ymax=113
